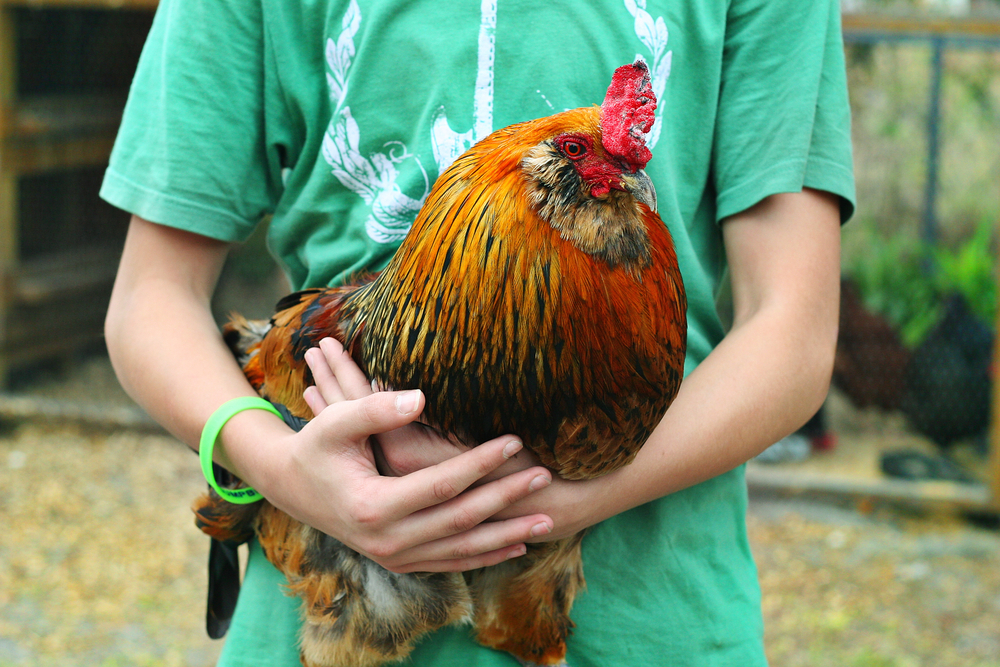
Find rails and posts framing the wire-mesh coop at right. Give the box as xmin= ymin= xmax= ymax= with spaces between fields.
xmin=746 ymin=14 xmax=1000 ymax=514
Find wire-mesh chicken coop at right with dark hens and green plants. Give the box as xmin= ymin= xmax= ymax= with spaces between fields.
xmin=747 ymin=14 xmax=1000 ymax=513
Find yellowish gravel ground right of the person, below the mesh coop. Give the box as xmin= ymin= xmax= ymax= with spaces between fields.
xmin=748 ymin=497 xmax=1000 ymax=667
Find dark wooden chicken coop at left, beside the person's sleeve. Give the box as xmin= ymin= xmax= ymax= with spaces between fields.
xmin=0 ymin=0 xmax=155 ymax=384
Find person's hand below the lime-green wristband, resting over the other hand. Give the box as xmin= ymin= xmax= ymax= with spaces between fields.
xmin=259 ymin=340 xmax=552 ymax=572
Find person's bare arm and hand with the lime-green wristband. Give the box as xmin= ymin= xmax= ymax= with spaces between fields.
xmin=105 ymin=217 xmax=551 ymax=571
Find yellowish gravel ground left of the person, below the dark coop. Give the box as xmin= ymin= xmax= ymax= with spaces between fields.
xmin=0 ymin=423 xmax=219 ymax=667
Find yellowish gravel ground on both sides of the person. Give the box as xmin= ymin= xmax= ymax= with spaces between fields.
xmin=0 ymin=360 xmax=1000 ymax=667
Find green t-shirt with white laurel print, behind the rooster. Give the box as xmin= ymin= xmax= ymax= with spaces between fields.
xmin=101 ymin=0 xmax=854 ymax=667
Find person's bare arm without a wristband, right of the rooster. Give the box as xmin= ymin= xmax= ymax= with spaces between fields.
xmin=501 ymin=189 xmax=840 ymax=539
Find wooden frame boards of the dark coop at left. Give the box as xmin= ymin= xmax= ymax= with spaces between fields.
xmin=0 ymin=0 xmax=157 ymax=386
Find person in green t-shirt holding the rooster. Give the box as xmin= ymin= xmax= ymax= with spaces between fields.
xmin=102 ymin=0 xmax=853 ymax=667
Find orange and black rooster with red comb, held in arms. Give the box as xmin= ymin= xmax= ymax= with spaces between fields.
xmin=195 ymin=60 xmax=687 ymax=667
